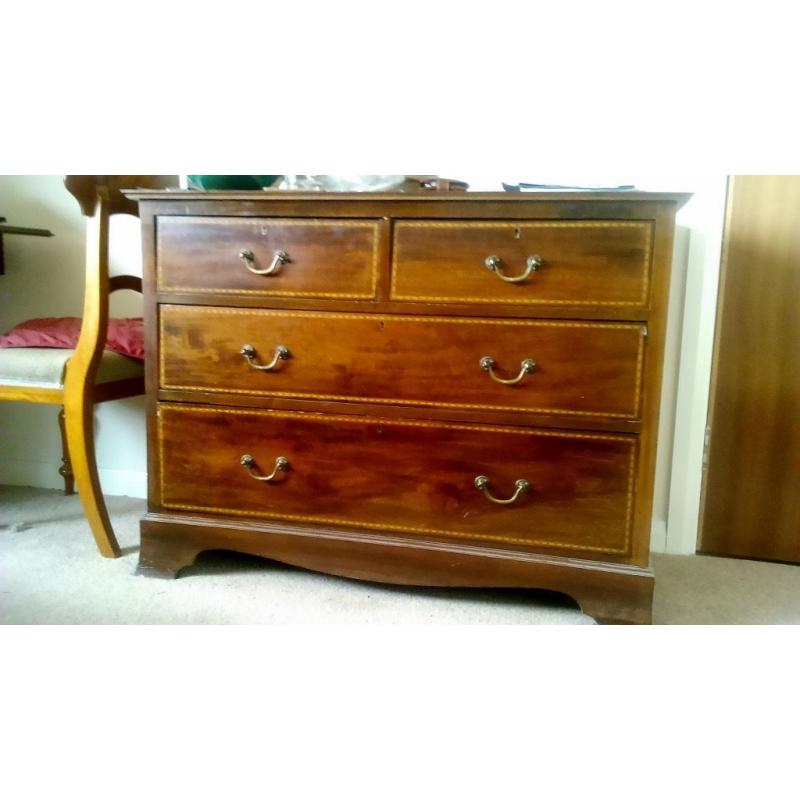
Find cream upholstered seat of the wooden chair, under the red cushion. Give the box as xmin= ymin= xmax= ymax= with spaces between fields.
xmin=0 ymin=347 xmax=144 ymax=389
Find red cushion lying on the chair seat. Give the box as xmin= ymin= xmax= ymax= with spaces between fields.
xmin=0 ymin=317 xmax=144 ymax=361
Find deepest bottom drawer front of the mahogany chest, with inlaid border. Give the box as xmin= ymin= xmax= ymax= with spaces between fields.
xmin=158 ymin=404 xmax=636 ymax=554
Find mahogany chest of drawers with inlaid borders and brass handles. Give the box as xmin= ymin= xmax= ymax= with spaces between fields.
xmin=129 ymin=191 xmax=687 ymax=622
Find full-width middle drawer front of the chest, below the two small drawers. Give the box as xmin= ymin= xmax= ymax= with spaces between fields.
xmin=160 ymin=305 xmax=644 ymax=419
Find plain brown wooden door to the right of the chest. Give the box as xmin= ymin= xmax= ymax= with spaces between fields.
xmin=698 ymin=175 xmax=800 ymax=562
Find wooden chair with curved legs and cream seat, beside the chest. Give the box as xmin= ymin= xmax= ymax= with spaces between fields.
xmin=0 ymin=175 xmax=178 ymax=558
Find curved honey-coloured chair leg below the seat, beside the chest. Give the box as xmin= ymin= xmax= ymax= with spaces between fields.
xmin=64 ymin=393 xmax=120 ymax=558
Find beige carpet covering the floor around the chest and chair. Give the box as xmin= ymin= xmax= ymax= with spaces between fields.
xmin=0 ymin=486 xmax=800 ymax=625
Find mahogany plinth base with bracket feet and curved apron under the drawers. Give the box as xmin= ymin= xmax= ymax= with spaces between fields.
xmin=137 ymin=512 xmax=654 ymax=624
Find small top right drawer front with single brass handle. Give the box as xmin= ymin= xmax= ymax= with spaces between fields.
xmin=391 ymin=221 xmax=653 ymax=307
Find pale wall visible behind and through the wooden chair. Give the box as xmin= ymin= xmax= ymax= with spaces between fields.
xmin=0 ymin=175 xmax=147 ymax=497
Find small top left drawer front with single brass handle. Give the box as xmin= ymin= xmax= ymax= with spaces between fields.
xmin=156 ymin=217 xmax=379 ymax=300
